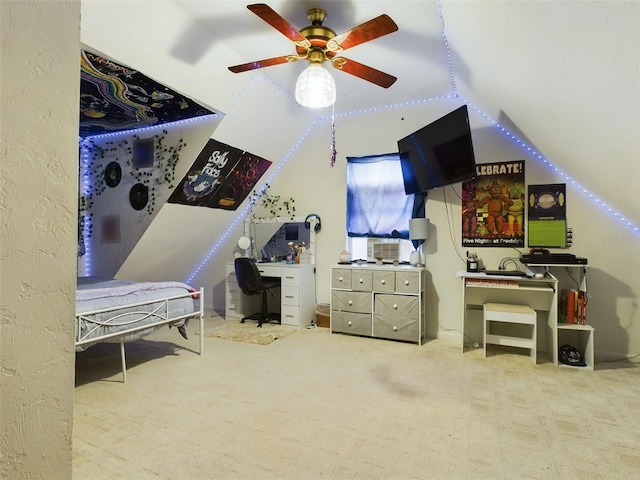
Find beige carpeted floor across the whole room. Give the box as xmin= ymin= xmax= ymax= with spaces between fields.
xmin=73 ymin=310 xmax=640 ymax=480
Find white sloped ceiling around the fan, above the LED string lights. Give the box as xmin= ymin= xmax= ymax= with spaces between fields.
xmin=81 ymin=0 xmax=640 ymax=224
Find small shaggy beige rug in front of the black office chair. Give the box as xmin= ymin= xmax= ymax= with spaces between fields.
xmin=204 ymin=317 xmax=296 ymax=345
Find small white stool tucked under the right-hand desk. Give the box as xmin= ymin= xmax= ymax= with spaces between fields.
xmin=483 ymin=303 xmax=538 ymax=365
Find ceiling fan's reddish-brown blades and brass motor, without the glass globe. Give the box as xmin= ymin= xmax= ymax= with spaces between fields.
xmin=229 ymin=3 xmax=398 ymax=88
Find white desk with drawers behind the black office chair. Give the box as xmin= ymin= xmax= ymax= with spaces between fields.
xmin=225 ymin=262 xmax=316 ymax=328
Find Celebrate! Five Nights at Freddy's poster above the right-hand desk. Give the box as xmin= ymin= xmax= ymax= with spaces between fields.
xmin=462 ymin=160 xmax=526 ymax=247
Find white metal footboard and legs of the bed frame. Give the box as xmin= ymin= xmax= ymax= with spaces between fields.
xmin=75 ymin=288 xmax=204 ymax=383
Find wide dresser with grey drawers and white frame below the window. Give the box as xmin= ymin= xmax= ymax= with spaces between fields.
xmin=331 ymin=264 xmax=426 ymax=345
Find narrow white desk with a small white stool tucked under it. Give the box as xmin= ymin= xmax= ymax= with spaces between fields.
xmin=457 ymin=271 xmax=558 ymax=365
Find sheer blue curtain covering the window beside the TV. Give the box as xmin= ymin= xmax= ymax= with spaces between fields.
xmin=347 ymin=153 xmax=414 ymax=239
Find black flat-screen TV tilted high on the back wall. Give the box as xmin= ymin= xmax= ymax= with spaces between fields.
xmin=398 ymin=105 xmax=476 ymax=195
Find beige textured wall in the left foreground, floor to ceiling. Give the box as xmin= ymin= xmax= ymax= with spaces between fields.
xmin=0 ymin=0 xmax=80 ymax=479
